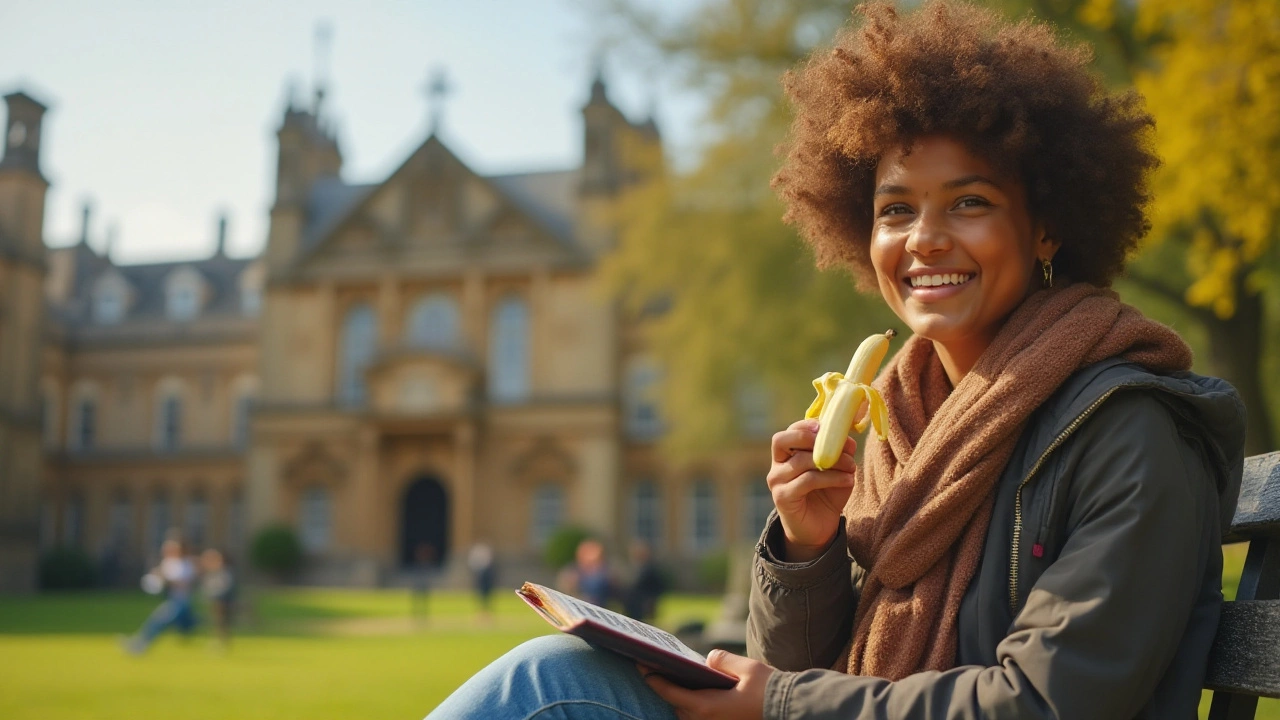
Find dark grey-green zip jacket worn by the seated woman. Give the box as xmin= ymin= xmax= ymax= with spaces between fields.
xmin=748 ymin=360 xmax=1244 ymax=720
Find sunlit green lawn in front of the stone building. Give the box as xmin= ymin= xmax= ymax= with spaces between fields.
xmin=0 ymin=548 xmax=1280 ymax=720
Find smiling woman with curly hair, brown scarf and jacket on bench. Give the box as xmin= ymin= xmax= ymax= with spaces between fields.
xmin=427 ymin=1 xmax=1244 ymax=720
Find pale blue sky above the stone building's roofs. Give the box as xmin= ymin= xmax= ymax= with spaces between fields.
xmin=0 ymin=0 xmax=699 ymax=263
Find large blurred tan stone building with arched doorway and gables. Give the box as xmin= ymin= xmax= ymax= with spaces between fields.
xmin=0 ymin=77 xmax=772 ymax=589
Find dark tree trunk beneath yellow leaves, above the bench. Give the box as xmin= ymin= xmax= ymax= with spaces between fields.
xmin=1204 ymin=287 xmax=1275 ymax=455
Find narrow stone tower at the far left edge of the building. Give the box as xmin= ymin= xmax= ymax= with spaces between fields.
xmin=0 ymin=92 xmax=49 ymax=592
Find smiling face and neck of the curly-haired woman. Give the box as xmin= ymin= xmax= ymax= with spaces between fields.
xmin=870 ymin=136 xmax=1057 ymax=383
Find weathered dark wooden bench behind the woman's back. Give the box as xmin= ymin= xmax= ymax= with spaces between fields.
xmin=1204 ymin=452 xmax=1280 ymax=720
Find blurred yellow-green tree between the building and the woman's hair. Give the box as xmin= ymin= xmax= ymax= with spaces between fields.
xmin=593 ymin=0 xmax=896 ymax=457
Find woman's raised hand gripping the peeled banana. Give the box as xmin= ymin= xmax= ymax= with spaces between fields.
xmin=768 ymin=419 xmax=858 ymax=562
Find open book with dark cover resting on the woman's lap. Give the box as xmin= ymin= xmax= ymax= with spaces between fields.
xmin=516 ymin=583 xmax=737 ymax=689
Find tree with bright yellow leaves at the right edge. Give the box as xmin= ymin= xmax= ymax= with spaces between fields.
xmin=1078 ymin=0 xmax=1280 ymax=454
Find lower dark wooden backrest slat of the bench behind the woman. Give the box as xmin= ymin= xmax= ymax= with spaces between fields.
xmin=1204 ymin=600 xmax=1280 ymax=698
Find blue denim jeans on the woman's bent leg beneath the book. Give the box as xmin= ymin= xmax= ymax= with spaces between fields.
xmin=428 ymin=634 xmax=676 ymax=720
